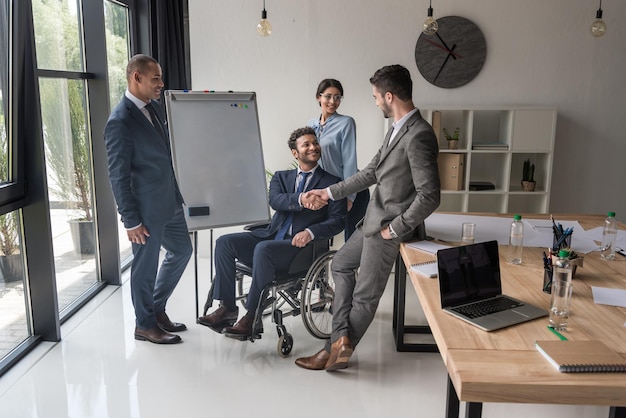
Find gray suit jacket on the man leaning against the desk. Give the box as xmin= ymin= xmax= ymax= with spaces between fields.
xmin=330 ymin=111 xmax=440 ymax=241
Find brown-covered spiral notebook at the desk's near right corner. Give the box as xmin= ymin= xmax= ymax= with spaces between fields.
xmin=535 ymin=341 xmax=626 ymax=373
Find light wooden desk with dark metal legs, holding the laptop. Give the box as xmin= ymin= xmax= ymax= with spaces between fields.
xmin=394 ymin=214 xmax=626 ymax=418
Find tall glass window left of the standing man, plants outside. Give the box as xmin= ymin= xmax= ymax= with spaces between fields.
xmin=32 ymin=0 xmax=100 ymax=312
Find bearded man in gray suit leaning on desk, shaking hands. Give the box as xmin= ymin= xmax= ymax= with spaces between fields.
xmin=296 ymin=65 xmax=440 ymax=371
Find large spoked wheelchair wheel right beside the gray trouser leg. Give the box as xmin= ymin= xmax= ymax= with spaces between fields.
xmin=301 ymin=251 xmax=336 ymax=339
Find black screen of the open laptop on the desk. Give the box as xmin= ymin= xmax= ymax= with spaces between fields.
xmin=437 ymin=241 xmax=502 ymax=308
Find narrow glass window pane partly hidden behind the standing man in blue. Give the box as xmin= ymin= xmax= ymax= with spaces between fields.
xmin=104 ymin=0 xmax=132 ymax=260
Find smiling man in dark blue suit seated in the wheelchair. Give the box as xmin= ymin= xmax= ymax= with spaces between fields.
xmin=198 ymin=127 xmax=347 ymax=336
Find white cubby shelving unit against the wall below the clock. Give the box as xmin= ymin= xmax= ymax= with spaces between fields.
xmin=420 ymin=108 xmax=557 ymax=213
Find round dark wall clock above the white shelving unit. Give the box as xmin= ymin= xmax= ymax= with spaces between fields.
xmin=415 ymin=16 xmax=487 ymax=89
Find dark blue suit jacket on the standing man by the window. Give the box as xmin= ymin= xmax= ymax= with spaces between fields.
xmin=104 ymin=97 xmax=183 ymax=228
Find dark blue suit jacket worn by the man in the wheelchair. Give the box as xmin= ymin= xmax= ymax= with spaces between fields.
xmin=250 ymin=167 xmax=347 ymax=240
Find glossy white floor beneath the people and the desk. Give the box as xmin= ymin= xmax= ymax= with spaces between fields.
xmin=0 ymin=258 xmax=609 ymax=418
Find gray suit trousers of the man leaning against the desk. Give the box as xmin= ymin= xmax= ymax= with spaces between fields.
xmin=325 ymin=227 xmax=400 ymax=352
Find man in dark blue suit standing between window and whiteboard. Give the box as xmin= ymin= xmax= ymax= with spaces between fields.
xmin=104 ymin=54 xmax=192 ymax=344
